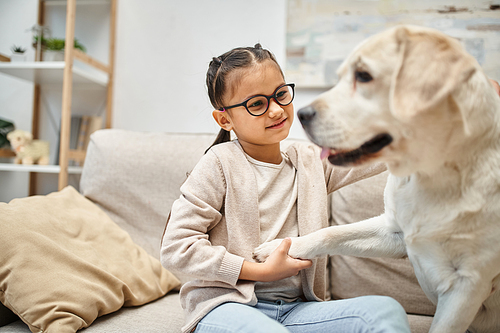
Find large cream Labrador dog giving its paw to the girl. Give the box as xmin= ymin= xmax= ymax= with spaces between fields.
xmin=254 ymin=26 xmax=500 ymax=333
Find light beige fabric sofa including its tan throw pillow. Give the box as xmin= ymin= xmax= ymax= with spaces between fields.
xmin=0 ymin=129 xmax=435 ymax=333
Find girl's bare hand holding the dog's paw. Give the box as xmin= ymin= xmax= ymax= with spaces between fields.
xmin=239 ymin=238 xmax=312 ymax=282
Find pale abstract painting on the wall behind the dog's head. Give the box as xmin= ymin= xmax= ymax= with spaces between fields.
xmin=285 ymin=0 xmax=500 ymax=88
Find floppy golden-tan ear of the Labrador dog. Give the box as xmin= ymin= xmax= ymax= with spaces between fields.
xmin=390 ymin=27 xmax=476 ymax=119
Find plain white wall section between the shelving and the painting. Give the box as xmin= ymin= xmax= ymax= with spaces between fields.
xmin=113 ymin=0 xmax=316 ymax=137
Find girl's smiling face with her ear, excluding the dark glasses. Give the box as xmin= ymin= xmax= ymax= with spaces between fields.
xmin=213 ymin=60 xmax=294 ymax=163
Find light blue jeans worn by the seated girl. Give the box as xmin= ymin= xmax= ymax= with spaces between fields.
xmin=195 ymin=296 xmax=410 ymax=333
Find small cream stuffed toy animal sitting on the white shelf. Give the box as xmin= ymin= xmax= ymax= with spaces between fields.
xmin=7 ymin=130 xmax=49 ymax=165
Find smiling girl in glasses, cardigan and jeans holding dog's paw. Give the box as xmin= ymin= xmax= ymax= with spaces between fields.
xmin=161 ymin=44 xmax=410 ymax=333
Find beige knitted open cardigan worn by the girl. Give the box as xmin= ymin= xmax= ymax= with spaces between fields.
xmin=161 ymin=142 xmax=385 ymax=332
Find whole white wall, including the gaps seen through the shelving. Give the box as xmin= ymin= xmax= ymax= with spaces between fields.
xmin=0 ymin=0 xmax=321 ymax=201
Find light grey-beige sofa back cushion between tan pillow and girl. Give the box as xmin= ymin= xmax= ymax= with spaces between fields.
xmin=80 ymin=129 xmax=215 ymax=259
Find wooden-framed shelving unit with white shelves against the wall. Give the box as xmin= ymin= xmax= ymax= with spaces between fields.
xmin=0 ymin=0 xmax=117 ymax=195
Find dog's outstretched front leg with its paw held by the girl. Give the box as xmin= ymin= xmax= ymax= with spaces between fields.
xmin=254 ymin=214 xmax=406 ymax=262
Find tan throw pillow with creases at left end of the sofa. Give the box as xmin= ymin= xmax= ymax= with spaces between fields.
xmin=0 ymin=187 xmax=179 ymax=333
